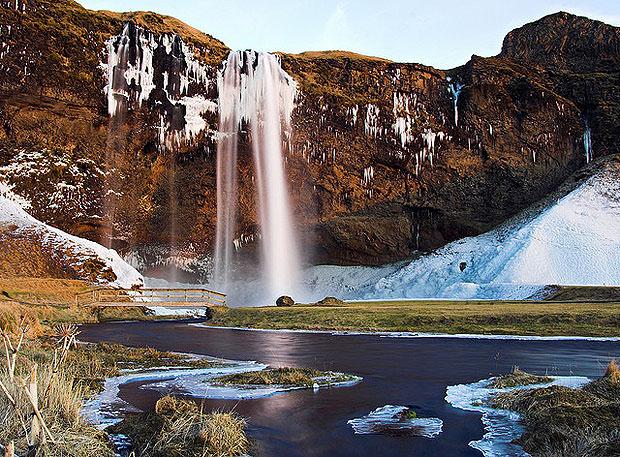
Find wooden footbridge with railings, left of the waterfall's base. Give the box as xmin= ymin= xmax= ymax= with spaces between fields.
xmin=75 ymin=288 xmax=226 ymax=308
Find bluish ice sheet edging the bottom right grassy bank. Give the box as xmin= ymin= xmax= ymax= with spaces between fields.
xmin=446 ymin=376 xmax=589 ymax=457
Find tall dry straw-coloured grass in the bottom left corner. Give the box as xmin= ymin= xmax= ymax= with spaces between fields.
xmin=0 ymin=318 xmax=114 ymax=457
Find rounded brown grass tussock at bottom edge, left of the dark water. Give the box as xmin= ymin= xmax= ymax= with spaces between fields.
xmin=111 ymin=396 xmax=249 ymax=457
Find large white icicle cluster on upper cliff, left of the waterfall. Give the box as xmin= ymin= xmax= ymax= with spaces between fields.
xmin=102 ymin=23 xmax=217 ymax=149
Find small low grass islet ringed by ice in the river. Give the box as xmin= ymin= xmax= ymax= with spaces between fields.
xmin=215 ymin=367 xmax=324 ymax=387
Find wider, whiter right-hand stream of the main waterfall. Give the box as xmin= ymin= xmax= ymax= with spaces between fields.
xmin=247 ymin=53 xmax=299 ymax=300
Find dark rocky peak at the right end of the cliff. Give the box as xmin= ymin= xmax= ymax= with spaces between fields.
xmin=500 ymin=13 xmax=620 ymax=162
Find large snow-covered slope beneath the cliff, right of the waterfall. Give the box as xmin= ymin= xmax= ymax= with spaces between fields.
xmin=307 ymin=162 xmax=620 ymax=299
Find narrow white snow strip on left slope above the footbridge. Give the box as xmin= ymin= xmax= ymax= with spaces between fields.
xmin=0 ymin=194 xmax=144 ymax=288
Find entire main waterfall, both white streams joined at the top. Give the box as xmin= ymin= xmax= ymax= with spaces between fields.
xmin=214 ymin=51 xmax=299 ymax=301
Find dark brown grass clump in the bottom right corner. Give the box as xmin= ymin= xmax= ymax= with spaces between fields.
xmin=491 ymin=361 xmax=620 ymax=457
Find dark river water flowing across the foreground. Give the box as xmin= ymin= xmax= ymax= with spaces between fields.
xmin=80 ymin=322 xmax=620 ymax=457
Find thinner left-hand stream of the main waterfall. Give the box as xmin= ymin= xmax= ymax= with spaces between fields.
xmin=213 ymin=52 xmax=241 ymax=291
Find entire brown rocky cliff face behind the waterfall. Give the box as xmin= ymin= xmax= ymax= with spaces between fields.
xmin=0 ymin=0 xmax=620 ymax=278
